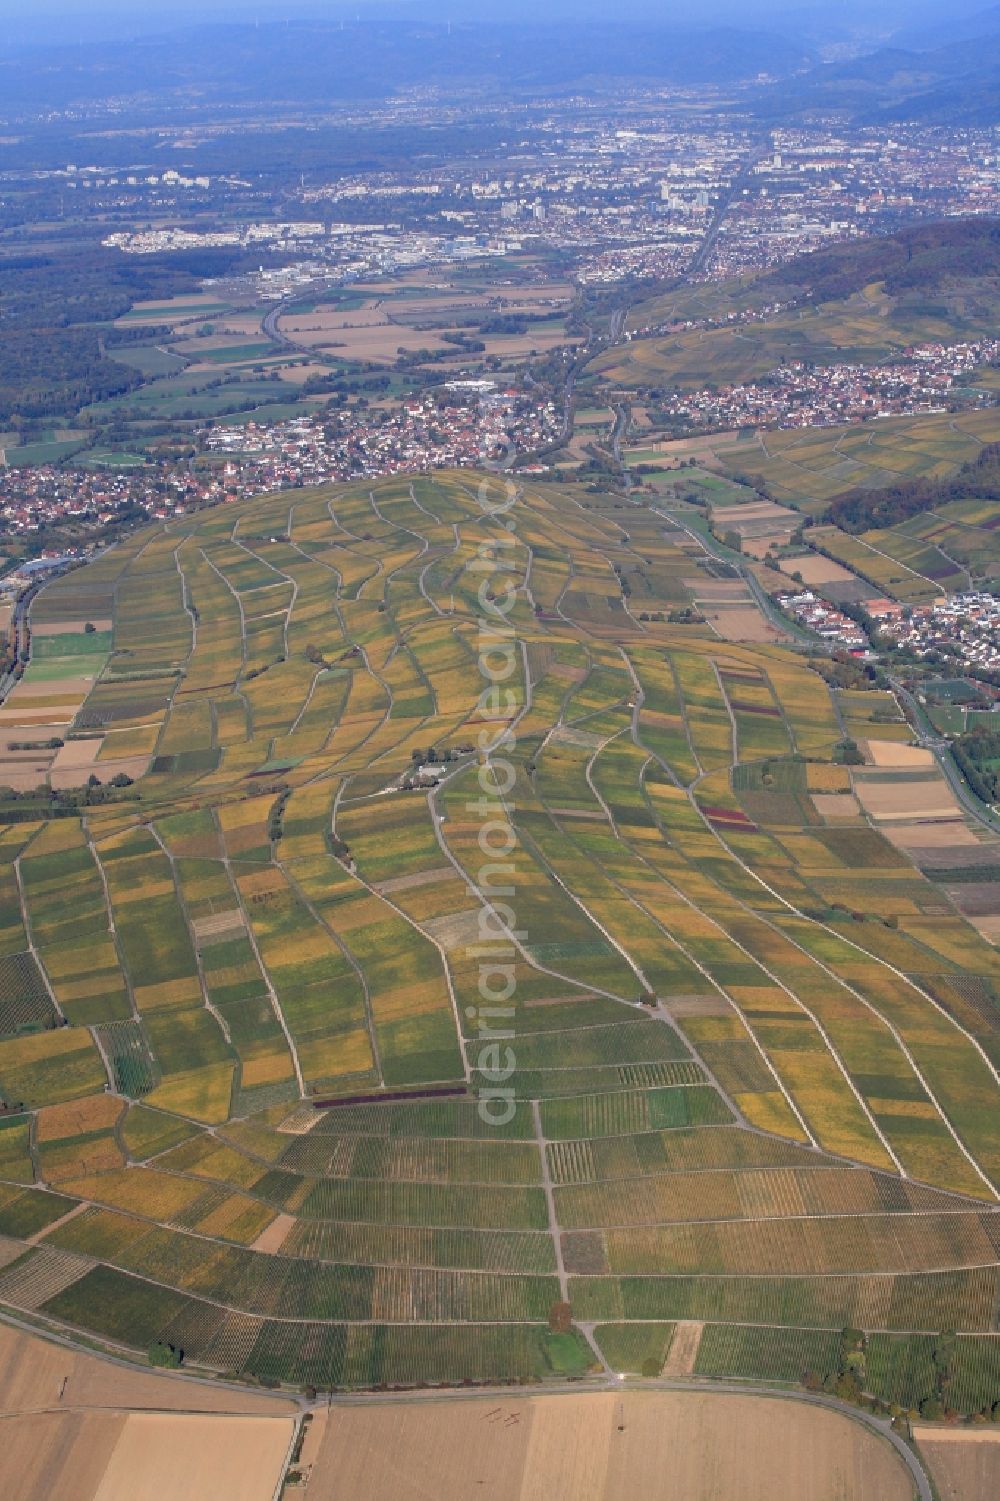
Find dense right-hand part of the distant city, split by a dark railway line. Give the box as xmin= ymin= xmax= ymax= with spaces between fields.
xmin=453 ymin=121 xmax=1000 ymax=284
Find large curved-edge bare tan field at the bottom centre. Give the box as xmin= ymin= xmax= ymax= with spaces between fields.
xmin=306 ymin=1391 xmax=911 ymax=1501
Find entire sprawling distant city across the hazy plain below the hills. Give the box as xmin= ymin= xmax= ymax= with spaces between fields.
xmin=15 ymin=109 xmax=1000 ymax=300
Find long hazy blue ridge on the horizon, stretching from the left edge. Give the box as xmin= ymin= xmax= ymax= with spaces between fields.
xmin=0 ymin=21 xmax=811 ymax=108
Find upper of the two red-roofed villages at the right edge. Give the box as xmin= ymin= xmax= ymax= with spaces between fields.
xmin=642 ymin=338 xmax=1000 ymax=428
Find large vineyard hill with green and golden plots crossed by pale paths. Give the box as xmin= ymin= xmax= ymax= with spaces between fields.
xmin=0 ymin=473 xmax=1000 ymax=1406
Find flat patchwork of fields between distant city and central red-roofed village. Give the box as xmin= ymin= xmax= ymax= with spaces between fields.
xmin=42 ymin=255 xmax=583 ymax=468
